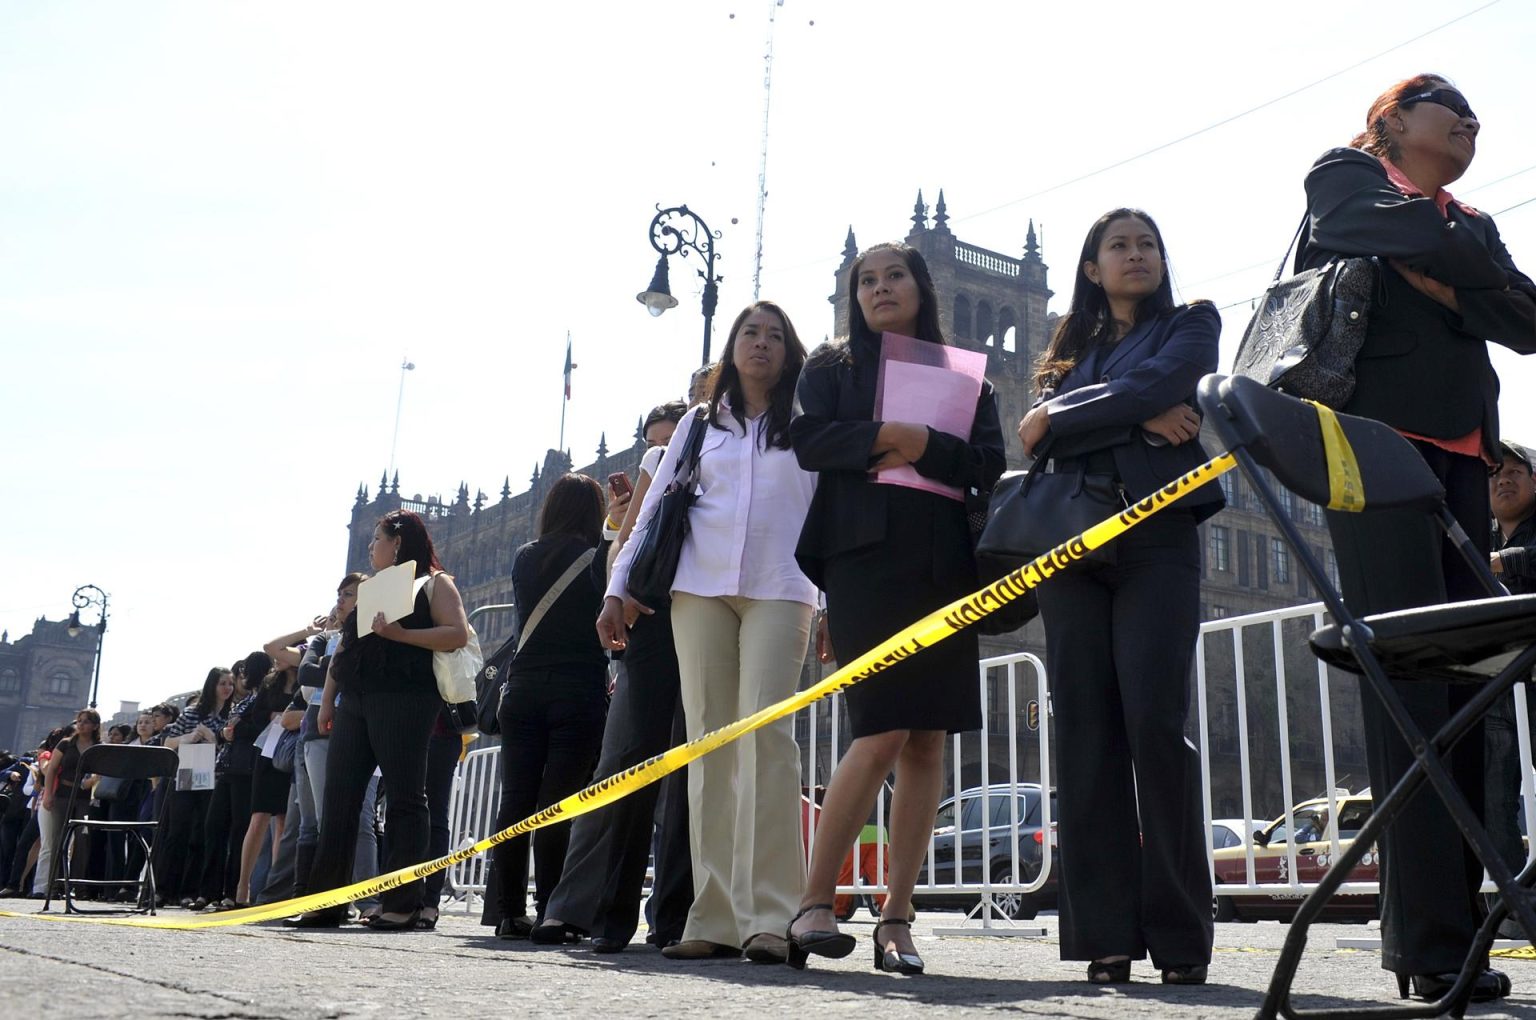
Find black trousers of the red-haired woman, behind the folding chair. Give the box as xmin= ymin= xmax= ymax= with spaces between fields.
xmin=1327 ymin=441 xmax=1490 ymax=974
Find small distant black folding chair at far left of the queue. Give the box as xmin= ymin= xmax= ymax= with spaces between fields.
xmin=43 ymin=743 xmax=177 ymax=914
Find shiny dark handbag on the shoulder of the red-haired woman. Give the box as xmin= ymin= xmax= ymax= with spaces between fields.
xmin=1232 ymin=215 xmax=1382 ymax=409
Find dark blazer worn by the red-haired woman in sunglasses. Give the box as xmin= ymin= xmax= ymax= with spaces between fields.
xmin=1296 ymin=149 xmax=1536 ymax=461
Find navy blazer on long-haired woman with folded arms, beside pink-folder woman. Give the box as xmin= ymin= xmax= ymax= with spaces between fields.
xmin=1043 ymin=301 xmax=1224 ymax=521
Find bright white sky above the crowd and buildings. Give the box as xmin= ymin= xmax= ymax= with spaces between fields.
xmin=0 ymin=0 xmax=1536 ymax=710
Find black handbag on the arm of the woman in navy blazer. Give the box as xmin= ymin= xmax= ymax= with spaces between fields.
xmin=975 ymin=447 xmax=1127 ymax=570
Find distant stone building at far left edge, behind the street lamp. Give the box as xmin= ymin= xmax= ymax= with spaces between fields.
xmin=0 ymin=618 xmax=97 ymax=750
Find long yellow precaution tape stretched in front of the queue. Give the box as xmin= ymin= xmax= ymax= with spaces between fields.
xmin=0 ymin=453 xmax=1236 ymax=931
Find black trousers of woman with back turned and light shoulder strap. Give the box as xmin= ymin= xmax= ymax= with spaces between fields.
xmin=495 ymin=673 xmax=608 ymax=920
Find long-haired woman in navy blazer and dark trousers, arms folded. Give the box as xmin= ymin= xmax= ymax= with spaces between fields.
xmin=1018 ymin=209 xmax=1223 ymax=985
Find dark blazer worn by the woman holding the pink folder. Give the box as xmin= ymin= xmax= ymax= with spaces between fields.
xmin=790 ymin=343 xmax=1003 ymax=587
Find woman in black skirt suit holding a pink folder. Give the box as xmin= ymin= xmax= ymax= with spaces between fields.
xmin=788 ymin=244 xmax=1003 ymax=974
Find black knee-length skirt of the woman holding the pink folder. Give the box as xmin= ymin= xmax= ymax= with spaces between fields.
xmin=825 ymin=485 xmax=982 ymax=737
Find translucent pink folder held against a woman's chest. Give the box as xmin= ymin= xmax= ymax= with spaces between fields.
xmin=874 ymin=333 xmax=986 ymax=501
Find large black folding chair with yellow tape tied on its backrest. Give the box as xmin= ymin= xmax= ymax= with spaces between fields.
xmin=1200 ymin=375 xmax=1536 ymax=1020
